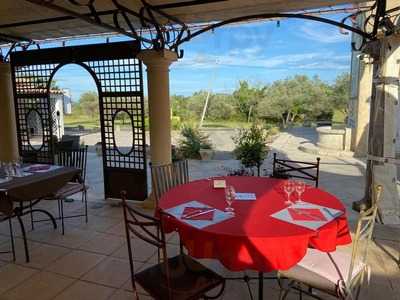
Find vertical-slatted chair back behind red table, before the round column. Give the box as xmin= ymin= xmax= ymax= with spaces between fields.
xmin=151 ymin=160 xmax=189 ymax=202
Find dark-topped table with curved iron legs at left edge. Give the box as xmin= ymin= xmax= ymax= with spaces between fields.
xmin=0 ymin=165 xmax=81 ymax=262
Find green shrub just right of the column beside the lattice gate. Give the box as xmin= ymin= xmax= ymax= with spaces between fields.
xmin=179 ymin=125 xmax=212 ymax=159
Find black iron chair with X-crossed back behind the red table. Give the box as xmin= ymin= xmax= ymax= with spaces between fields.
xmin=272 ymin=153 xmax=321 ymax=187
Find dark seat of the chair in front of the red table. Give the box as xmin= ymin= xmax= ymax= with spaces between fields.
xmin=135 ymin=254 xmax=224 ymax=300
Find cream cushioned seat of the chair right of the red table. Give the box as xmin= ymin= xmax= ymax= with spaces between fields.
xmin=280 ymin=248 xmax=365 ymax=295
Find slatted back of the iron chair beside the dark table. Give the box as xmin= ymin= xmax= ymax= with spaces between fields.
xmin=57 ymin=146 xmax=88 ymax=182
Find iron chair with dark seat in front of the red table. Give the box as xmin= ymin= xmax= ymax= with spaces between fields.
xmin=121 ymin=192 xmax=225 ymax=300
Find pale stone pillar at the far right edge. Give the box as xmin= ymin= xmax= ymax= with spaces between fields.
xmin=353 ymin=35 xmax=400 ymax=224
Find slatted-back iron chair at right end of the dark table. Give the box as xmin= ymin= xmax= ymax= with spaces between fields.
xmin=38 ymin=146 xmax=88 ymax=234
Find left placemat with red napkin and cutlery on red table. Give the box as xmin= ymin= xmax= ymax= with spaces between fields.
xmin=165 ymin=200 xmax=233 ymax=229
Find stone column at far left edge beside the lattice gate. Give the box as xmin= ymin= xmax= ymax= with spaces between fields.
xmin=0 ymin=61 xmax=18 ymax=161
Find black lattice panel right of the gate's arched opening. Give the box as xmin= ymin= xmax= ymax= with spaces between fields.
xmin=86 ymin=58 xmax=145 ymax=170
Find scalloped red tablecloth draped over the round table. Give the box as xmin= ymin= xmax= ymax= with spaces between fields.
xmin=159 ymin=177 xmax=351 ymax=272
